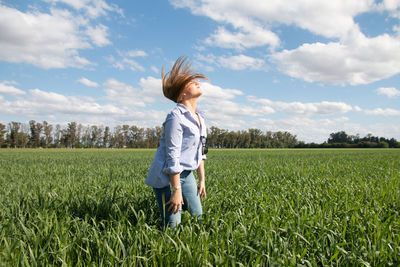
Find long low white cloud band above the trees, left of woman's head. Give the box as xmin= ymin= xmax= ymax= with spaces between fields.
xmin=0 ymin=77 xmax=166 ymax=127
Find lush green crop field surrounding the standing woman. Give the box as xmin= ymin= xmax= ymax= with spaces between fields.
xmin=0 ymin=149 xmax=400 ymax=266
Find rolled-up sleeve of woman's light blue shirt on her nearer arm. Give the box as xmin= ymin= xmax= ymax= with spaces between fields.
xmin=163 ymin=113 xmax=183 ymax=174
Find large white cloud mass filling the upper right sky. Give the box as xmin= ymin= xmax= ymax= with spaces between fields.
xmin=170 ymin=0 xmax=400 ymax=85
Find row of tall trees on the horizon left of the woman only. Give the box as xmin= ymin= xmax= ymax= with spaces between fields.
xmin=0 ymin=120 xmax=162 ymax=148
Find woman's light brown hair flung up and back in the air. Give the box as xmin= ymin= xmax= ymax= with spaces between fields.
xmin=161 ymin=57 xmax=208 ymax=103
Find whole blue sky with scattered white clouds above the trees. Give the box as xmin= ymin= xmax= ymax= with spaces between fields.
xmin=0 ymin=0 xmax=400 ymax=142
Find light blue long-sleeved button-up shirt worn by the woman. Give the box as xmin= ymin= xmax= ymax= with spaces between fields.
xmin=146 ymin=104 xmax=207 ymax=188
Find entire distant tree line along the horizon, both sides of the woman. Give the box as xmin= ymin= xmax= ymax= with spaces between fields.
xmin=0 ymin=120 xmax=400 ymax=148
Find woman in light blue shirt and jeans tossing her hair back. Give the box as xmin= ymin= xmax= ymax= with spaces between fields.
xmin=146 ymin=57 xmax=207 ymax=229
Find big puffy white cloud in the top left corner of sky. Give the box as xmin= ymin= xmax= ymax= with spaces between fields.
xmin=0 ymin=0 xmax=118 ymax=69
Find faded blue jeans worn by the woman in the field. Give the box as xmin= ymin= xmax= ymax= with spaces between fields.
xmin=153 ymin=171 xmax=203 ymax=229
